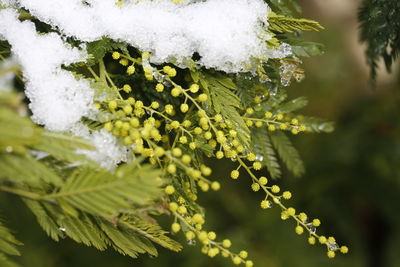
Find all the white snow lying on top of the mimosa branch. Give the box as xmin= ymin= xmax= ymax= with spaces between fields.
xmin=0 ymin=0 xmax=291 ymax=169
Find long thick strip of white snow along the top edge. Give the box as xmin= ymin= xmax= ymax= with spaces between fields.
xmin=18 ymin=0 xmax=284 ymax=72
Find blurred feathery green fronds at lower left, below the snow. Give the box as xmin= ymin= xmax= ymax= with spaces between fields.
xmin=0 ymin=92 xmax=181 ymax=266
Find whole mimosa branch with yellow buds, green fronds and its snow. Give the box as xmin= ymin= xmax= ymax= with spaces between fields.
xmin=0 ymin=0 xmax=348 ymax=267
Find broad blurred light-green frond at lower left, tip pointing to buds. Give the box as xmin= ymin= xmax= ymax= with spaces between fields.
xmin=43 ymin=162 xmax=161 ymax=216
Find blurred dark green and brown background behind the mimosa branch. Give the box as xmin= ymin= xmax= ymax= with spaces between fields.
xmin=0 ymin=0 xmax=400 ymax=267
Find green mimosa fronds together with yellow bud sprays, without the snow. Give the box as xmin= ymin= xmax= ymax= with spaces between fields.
xmin=0 ymin=0 xmax=347 ymax=267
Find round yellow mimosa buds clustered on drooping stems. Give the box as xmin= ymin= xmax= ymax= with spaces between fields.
xmin=92 ymin=49 xmax=348 ymax=267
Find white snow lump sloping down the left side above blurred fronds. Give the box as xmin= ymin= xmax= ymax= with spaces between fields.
xmin=0 ymin=10 xmax=93 ymax=131
